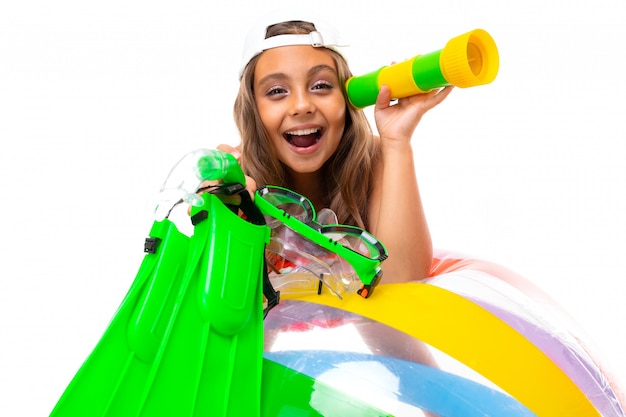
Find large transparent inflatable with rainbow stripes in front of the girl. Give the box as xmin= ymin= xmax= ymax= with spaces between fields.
xmin=262 ymin=252 xmax=626 ymax=417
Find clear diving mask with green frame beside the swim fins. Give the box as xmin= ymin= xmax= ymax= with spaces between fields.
xmin=254 ymin=186 xmax=387 ymax=298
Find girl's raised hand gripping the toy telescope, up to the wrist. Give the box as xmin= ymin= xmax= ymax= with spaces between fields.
xmin=374 ymin=85 xmax=452 ymax=142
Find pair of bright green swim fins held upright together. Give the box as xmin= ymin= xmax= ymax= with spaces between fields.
xmin=51 ymin=186 xmax=269 ymax=417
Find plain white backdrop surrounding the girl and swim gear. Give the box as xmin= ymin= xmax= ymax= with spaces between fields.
xmin=0 ymin=0 xmax=626 ymax=416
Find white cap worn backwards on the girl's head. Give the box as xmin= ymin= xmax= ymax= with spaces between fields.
xmin=239 ymin=12 xmax=348 ymax=78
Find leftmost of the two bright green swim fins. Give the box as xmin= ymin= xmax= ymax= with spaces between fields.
xmin=51 ymin=219 xmax=189 ymax=416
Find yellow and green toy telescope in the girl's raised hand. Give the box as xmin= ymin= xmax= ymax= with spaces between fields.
xmin=346 ymin=29 xmax=500 ymax=108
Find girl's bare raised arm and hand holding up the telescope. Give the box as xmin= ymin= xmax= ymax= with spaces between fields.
xmin=369 ymin=86 xmax=452 ymax=283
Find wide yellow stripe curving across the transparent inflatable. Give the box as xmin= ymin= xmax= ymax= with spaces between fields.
xmin=285 ymin=283 xmax=601 ymax=417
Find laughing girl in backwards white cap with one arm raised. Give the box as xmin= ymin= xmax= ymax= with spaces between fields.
xmin=219 ymin=14 xmax=451 ymax=283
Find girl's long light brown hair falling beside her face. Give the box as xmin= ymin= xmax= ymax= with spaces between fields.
xmin=234 ymin=21 xmax=379 ymax=228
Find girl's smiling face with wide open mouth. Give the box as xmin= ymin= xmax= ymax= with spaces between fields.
xmin=254 ymin=45 xmax=346 ymax=174
